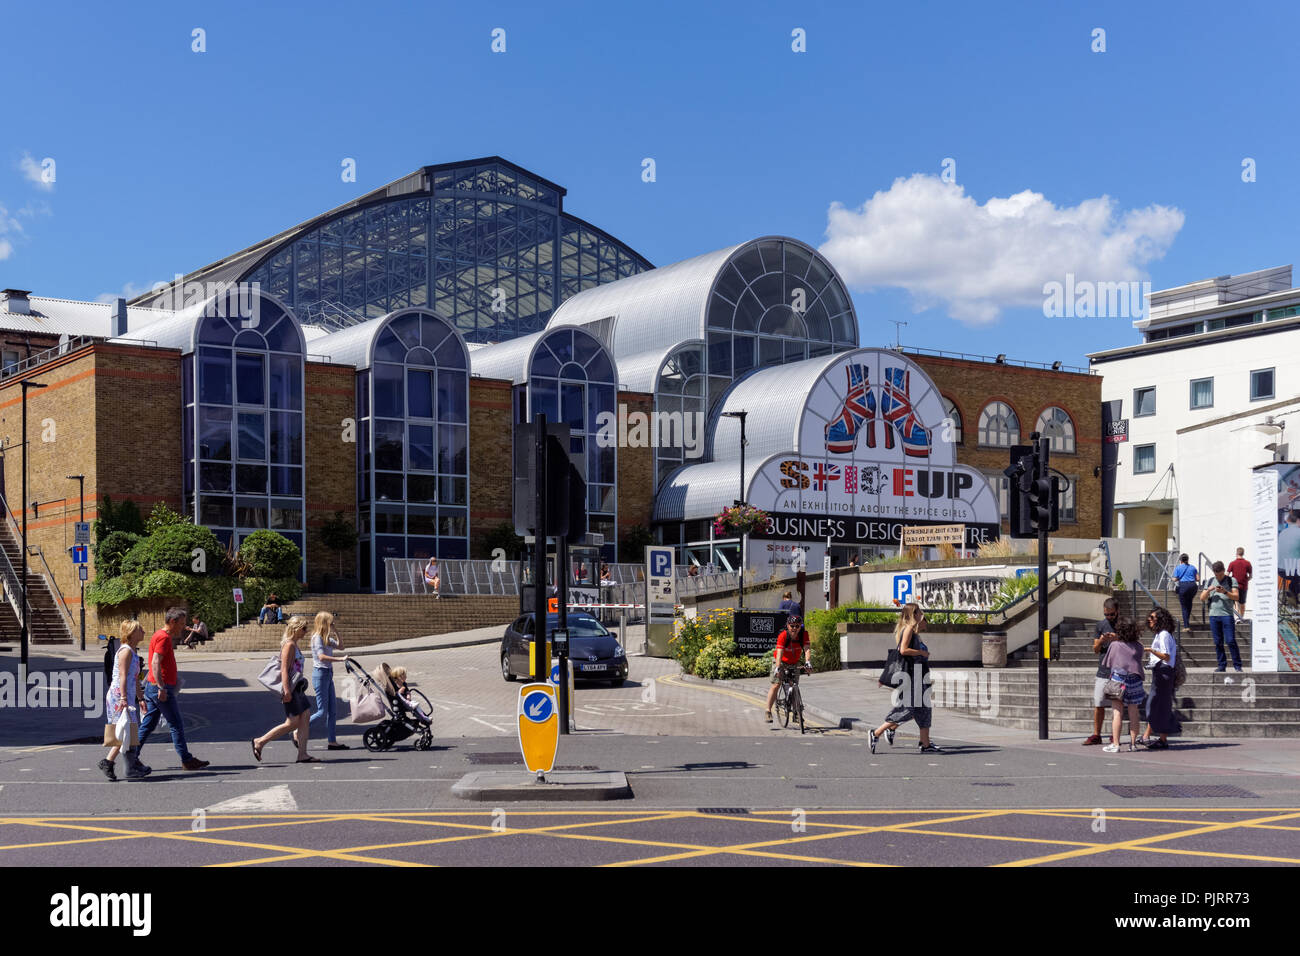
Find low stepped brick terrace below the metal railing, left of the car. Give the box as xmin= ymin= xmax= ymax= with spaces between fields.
xmin=202 ymin=594 xmax=519 ymax=652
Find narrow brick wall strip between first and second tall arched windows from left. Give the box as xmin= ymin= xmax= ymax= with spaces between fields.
xmin=303 ymin=362 xmax=360 ymax=589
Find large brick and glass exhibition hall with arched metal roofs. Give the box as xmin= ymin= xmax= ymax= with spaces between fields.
xmin=0 ymin=157 xmax=1100 ymax=606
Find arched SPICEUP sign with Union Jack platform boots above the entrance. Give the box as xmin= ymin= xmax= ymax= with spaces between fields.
xmin=748 ymin=349 xmax=1001 ymax=546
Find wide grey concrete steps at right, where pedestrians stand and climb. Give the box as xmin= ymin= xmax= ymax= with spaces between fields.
xmin=935 ymin=658 xmax=1300 ymax=740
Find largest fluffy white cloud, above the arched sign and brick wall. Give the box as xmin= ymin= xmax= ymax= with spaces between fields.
xmin=820 ymin=173 xmax=1184 ymax=325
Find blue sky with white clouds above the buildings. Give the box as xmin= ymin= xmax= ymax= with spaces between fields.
xmin=0 ymin=0 xmax=1300 ymax=364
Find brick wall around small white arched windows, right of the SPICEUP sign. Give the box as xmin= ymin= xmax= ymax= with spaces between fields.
xmin=905 ymin=350 xmax=1101 ymax=537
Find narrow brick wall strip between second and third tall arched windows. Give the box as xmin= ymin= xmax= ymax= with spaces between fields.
xmin=469 ymin=378 xmax=515 ymax=557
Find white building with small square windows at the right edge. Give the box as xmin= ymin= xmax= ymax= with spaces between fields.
xmin=1088 ymin=265 xmax=1300 ymax=587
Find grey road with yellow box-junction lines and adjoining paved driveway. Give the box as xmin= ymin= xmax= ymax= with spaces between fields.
xmin=0 ymin=633 xmax=1300 ymax=866
